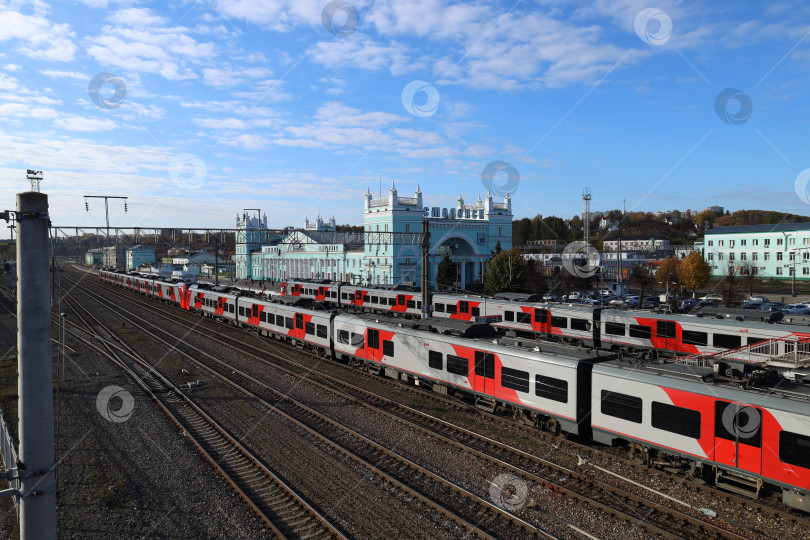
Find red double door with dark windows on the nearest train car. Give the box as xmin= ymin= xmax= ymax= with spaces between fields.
xmin=714 ymin=401 xmax=762 ymax=474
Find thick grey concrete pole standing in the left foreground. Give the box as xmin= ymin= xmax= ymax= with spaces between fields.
xmin=17 ymin=192 xmax=56 ymax=540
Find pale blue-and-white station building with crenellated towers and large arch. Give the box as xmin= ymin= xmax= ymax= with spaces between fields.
xmin=233 ymin=183 xmax=512 ymax=288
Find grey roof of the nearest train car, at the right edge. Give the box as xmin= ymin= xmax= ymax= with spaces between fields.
xmin=593 ymin=359 xmax=810 ymax=415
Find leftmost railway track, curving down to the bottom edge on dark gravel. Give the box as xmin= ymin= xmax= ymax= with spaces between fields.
xmin=55 ymin=284 xmax=345 ymax=539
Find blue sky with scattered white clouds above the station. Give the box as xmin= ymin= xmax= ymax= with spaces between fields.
xmin=0 ymin=0 xmax=810 ymax=238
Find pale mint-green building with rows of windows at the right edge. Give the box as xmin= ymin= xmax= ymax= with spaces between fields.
xmin=703 ymin=222 xmax=810 ymax=280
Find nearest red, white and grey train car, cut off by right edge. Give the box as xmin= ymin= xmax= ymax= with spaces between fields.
xmin=591 ymin=361 xmax=810 ymax=511
